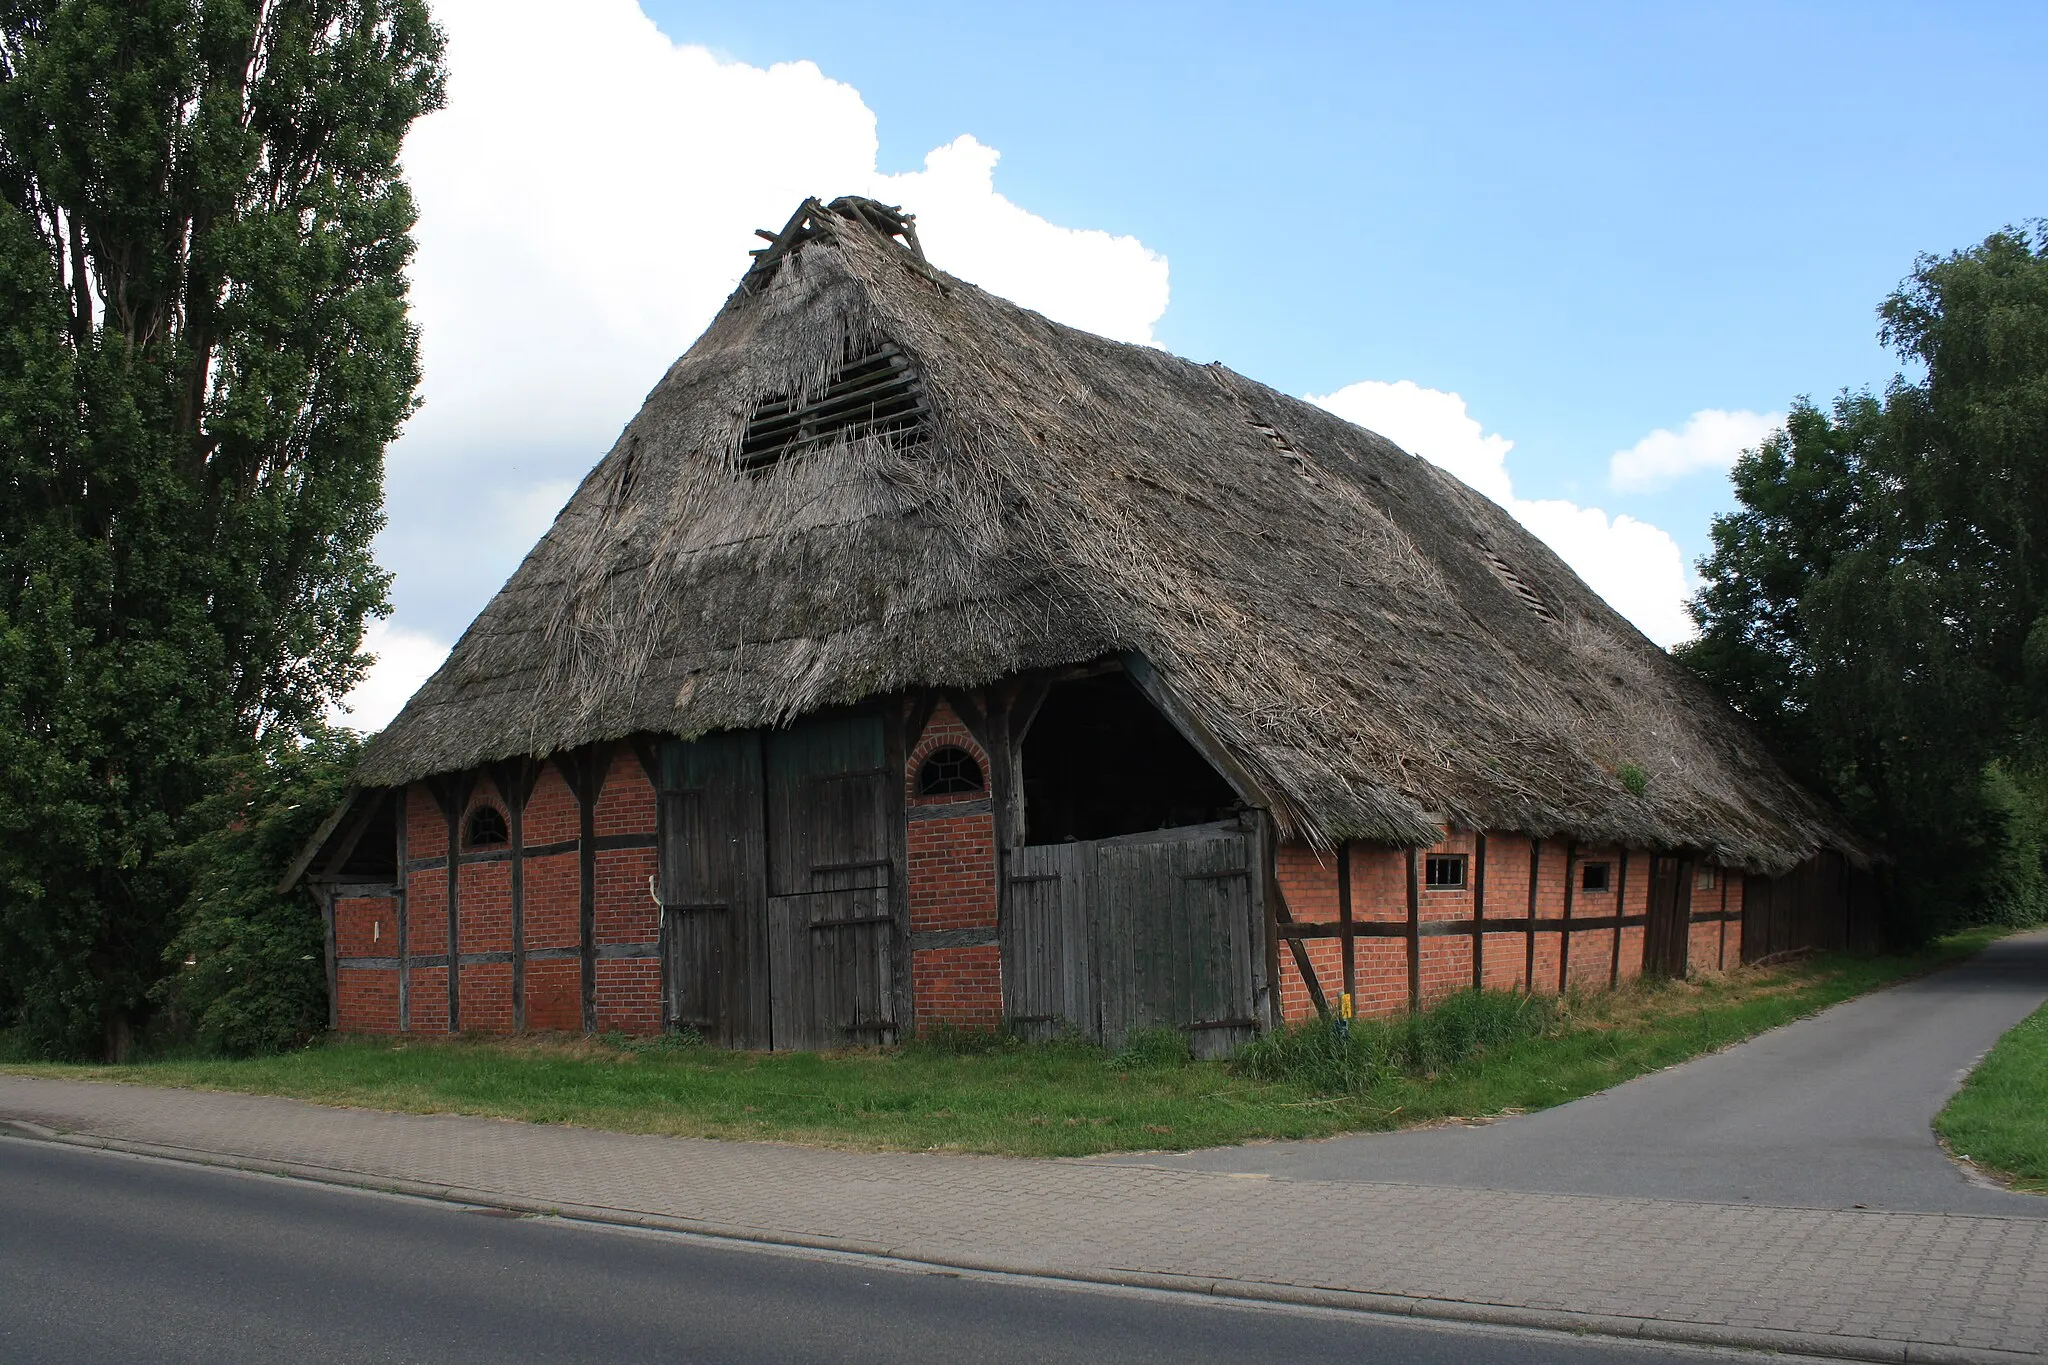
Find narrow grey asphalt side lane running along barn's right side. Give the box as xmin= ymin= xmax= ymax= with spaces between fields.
xmin=1112 ymin=933 xmax=2048 ymax=1218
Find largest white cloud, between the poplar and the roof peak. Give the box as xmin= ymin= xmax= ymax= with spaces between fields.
xmin=350 ymin=0 xmax=1167 ymax=722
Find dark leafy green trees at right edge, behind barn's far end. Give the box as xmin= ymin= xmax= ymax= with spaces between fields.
xmin=1679 ymin=225 xmax=2048 ymax=935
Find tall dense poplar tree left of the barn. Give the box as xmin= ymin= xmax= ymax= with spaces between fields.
xmin=0 ymin=0 xmax=442 ymax=1054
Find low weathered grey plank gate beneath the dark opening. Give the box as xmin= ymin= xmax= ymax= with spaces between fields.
xmin=1001 ymin=823 xmax=1264 ymax=1056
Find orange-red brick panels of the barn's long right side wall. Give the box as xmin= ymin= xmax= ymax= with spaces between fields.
xmin=1278 ymin=829 xmax=1743 ymax=1019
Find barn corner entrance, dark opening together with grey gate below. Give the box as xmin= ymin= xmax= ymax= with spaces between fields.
xmin=1001 ymin=671 xmax=1264 ymax=1056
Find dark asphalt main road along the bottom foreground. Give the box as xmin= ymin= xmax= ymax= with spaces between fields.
xmin=0 ymin=1140 xmax=1761 ymax=1365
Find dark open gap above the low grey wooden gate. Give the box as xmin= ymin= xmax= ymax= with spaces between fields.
xmin=1022 ymin=671 xmax=1239 ymax=843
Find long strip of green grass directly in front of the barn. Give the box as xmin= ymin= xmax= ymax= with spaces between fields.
xmin=0 ymin=931 xmax=1995 ymax=1156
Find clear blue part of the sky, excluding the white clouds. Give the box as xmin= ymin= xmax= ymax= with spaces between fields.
xmin=645 ymin=0 xmax=2048 ymax=519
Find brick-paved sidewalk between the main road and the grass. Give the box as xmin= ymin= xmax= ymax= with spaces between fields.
xmin=0 ymin=1076 xmax=2048 ymax=1361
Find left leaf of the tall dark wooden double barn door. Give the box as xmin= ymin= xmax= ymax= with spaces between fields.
xmin=659 ymin=733 xmax=770 ymax=1048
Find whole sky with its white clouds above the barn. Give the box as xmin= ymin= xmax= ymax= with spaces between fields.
xmin=346 ymin=0 xmax=2048 ymax=729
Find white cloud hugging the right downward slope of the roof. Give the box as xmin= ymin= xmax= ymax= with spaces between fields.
xmin=1309 ymin=379 xmax=1694 ymax=647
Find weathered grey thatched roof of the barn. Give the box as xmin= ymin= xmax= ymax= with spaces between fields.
xmin=358 ymin=201 xmax=1858 ymax=872
